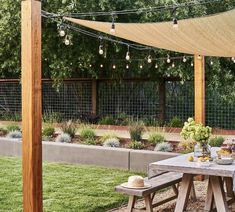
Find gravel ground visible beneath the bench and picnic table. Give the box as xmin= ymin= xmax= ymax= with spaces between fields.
xmin=111 ymin=181 xmax=235 ymax=212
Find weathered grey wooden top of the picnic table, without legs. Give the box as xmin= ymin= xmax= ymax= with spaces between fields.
xmin=148 ymin=148 xmax=235 ymax=178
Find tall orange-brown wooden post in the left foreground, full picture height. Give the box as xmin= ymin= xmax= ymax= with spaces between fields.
xmin=21 ymin=0 xmax=43 ymax=212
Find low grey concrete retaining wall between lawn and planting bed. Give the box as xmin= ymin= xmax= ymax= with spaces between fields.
xmin=0 ymin=138 xmax=177 ymax=172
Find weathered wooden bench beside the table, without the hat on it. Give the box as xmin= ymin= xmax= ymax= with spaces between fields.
xmin=115 ymin=172 xmax=182 ymax=212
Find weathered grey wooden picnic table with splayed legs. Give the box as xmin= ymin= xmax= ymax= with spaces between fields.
xmin=149 ymin=148 xmax=235 ymax=212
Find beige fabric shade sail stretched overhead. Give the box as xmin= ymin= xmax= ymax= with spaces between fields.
xmin=64 ymin=9 xmax=235 ymax=57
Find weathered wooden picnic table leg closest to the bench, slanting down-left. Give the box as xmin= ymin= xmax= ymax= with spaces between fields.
xmin=175 ymin=174 xmax=193 ymax=212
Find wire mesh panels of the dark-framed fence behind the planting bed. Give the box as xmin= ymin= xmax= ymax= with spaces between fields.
xmin=0 ymin=80 xmax=235 ymax=129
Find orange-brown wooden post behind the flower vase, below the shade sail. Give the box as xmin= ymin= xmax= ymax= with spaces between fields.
xmin=194 ymin=55 xmax=205 ymax=124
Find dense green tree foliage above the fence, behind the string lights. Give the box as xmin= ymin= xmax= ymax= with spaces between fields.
xmin=0 ymin=0 xmax=235 ymax=90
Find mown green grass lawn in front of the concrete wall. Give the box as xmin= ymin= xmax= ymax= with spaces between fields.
xmin=0 ymin=157 xmax=142 ymax=212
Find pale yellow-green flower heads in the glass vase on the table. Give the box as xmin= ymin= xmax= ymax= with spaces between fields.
xmin=180 ymin=118 xmax=212 ymax=145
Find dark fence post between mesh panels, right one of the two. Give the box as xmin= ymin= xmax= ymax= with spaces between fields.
xmin=159 ymin=79 xmax=166 ymax=122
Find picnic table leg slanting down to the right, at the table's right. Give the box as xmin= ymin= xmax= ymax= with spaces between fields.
xmin=209 ymin=176 xmax=228 ymax=212
